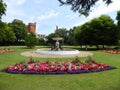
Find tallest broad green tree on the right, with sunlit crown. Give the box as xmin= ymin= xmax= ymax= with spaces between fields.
xmin=90 ymin=15 xmax=117 ymax=47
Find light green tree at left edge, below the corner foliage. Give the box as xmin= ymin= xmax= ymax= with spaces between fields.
xmin=0 ymin=21 xmax=16 ymax=45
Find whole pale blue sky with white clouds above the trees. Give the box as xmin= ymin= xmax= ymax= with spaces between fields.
xmin=2 ymin=0 xmax=120 ymax=35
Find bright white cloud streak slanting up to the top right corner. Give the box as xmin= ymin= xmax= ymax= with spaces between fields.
xmin=75 ymin=0 xmax=120 ymax=26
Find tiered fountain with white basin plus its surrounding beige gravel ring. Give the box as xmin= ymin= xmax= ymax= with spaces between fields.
xmin=22 ymin=27 xmax=92 ymax=58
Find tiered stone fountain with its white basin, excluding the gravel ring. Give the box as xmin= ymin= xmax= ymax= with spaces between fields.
xmin=36 ymin=26 xmax=79 ymax=55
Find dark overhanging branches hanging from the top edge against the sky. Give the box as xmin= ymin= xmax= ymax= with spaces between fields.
xmin=58 ymin=0 xmax=112 ymax=16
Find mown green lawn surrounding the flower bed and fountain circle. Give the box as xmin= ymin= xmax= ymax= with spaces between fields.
xmin=0 ymin=47 xmax=120 ymax=90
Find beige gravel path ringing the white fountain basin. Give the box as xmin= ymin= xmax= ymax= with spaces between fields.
xmin=21 ymin=51 xmax=93 ymax=58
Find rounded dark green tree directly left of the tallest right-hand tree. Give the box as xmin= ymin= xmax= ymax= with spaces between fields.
xmin=74 ymin=22 xmax=93 ymax=48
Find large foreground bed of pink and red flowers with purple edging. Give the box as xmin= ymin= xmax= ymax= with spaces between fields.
xmin=2 ymin=59 xmax=115 ymax=74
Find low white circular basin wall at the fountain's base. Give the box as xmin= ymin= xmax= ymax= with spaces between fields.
xmin=35 ymin=49 xmax=80 ymax=55
